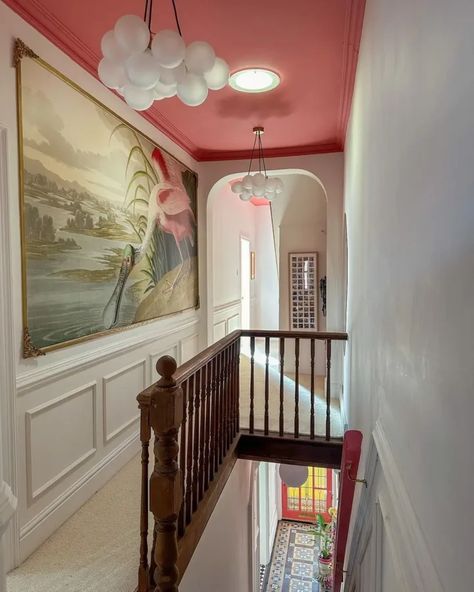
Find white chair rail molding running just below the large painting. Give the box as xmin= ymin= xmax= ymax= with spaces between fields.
xmin=16 ymin=318 xmax=199 ymax=395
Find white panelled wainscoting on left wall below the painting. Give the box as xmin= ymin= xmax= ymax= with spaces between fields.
xmin=15 ymin=311 xmax=199 ymax=564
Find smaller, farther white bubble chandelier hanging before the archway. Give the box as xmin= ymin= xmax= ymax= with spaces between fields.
xmin=232 ymin=126 xmax=283 ymax=201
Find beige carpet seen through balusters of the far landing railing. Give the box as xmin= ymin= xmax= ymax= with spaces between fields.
xmin=240 ymin=355 xmax=343 ymax=437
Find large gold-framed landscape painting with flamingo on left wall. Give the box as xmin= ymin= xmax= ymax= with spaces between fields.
xmin=15 ymin=40 xmax=199 ymax=357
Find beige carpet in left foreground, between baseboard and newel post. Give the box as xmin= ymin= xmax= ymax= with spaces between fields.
xmin=7 ymin=457 xmax=140 ymax=592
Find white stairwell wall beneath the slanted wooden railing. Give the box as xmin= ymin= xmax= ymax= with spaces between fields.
xmin=179 ymin=460 xmax=254 ymax=592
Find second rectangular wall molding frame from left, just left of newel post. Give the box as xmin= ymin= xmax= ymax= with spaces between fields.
xmin=102 ymin=358 xmax=147 ymax=444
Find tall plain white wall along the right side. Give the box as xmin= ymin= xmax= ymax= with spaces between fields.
xmin=345 ymin=0 xmax=474 ymax=592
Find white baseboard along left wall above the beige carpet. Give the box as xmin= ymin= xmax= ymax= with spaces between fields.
xmin=19 ymin=434 xmax=139 ymax=563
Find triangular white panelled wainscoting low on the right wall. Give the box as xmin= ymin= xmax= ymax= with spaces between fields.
xmin=346 ymin=421 xmax=443 ymax=592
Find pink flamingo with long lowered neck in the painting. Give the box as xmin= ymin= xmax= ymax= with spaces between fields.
xmin=103 ymin=148 xmax=196 ymax=329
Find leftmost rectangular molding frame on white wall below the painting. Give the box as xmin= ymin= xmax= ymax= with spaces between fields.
xmin=25 ymin=381 xmax=97 ymax=505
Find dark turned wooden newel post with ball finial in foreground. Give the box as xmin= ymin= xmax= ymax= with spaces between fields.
xmin=150 ymin=356 xmax=183 ymax=592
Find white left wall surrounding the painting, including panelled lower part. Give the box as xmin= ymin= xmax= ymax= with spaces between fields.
xmin=0 ymin=3 xmax=205 ymax=567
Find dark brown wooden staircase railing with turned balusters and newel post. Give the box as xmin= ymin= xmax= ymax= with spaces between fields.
xmin=137 ymin=330 xmax=347 ymax=592
